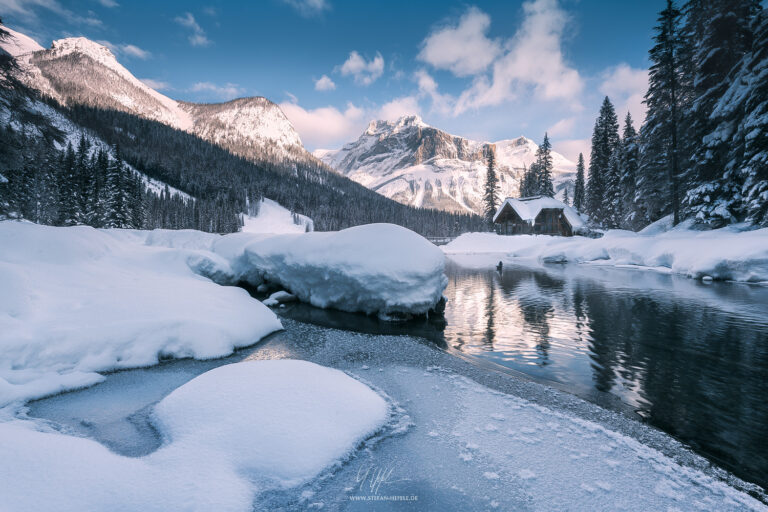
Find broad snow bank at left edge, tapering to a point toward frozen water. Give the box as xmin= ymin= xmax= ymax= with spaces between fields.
xmin=0 ymin=221 xmax=281 ymax=407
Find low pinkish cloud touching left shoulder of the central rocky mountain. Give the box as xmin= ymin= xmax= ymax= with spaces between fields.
xmin=280 ymin=102 xmax=365 ymax=148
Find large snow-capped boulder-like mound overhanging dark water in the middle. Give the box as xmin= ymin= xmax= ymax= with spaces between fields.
xmin=213 ymin=224 xmax=447 ymax=316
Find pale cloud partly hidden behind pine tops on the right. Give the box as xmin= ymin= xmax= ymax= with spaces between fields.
xmin=600 ymin=63 xmax=648 ymax=127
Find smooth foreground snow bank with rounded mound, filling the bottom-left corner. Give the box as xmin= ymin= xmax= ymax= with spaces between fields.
xmin=0 ymin=360 xmax=389 ymax=512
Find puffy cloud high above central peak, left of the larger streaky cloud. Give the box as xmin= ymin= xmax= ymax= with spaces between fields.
xmin=417 ymin=7 xmax=501 ymax=76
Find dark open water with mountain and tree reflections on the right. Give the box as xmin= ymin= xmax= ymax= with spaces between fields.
xmin=444 ymin=262 xmax=768 ymax=486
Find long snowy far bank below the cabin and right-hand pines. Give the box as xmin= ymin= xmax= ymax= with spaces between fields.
xmin=442 ymin=228 xmax=768 ymax=283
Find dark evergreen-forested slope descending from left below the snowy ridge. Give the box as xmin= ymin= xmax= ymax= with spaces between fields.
xmin=0 ymin=26 xmax=485 ymax=236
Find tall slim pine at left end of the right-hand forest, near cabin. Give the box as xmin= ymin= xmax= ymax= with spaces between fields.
xmin=587 ymin=96 xmax=619 ymax=224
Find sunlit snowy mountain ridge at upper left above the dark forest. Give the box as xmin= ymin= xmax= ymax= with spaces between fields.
xmin=0 ymin=27 xmax=308 ymax=159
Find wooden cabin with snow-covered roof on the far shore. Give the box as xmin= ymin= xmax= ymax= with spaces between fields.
xmin=493 ymin=196 xmax=585 ymax=236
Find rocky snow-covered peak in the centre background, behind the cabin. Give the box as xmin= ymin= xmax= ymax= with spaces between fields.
xmin=314 ymin=116 xmax=576 ymax=213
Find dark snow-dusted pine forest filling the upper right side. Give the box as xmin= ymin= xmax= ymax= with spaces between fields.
xmin=574 ymin=0 xmax=768 ymax=229
